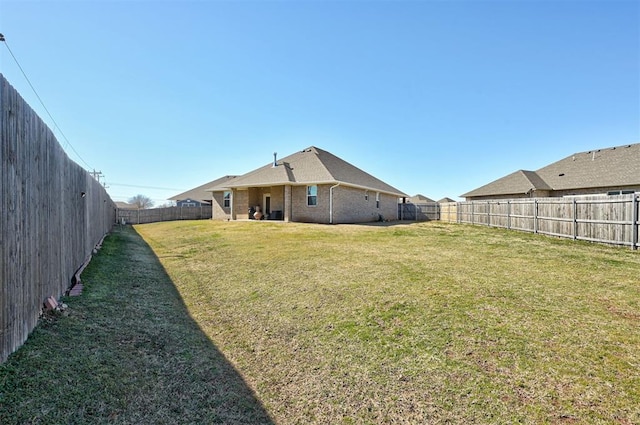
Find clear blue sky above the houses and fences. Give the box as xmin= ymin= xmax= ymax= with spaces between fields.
xmin=0 ymin=0 xmax=640 ymax=204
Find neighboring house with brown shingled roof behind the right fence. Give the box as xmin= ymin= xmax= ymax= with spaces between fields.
xmin=462 ymin=143 xmax=640 ymax=201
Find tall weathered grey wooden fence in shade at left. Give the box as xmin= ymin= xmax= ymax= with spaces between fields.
xmin=0 ymin=74 xmax=116 ymax=363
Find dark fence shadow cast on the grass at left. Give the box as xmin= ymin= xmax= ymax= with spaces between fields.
xmin=0 ymin=227 xmax=273 ymax=424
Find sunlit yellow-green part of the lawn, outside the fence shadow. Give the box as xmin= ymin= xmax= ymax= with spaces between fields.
xmin=139 ymin=222 xmax=640 ymax=424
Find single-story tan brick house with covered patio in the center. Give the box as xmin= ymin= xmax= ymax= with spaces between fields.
xmin=209 ymin=146 xmax=407 ymax=223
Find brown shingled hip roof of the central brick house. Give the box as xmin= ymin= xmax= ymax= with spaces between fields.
xmin=212 ymin=146 xmax=407 ymax=197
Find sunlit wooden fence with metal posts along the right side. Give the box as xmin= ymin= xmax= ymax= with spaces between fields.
xmin=452 ymin=194 xmax=640 ymax=249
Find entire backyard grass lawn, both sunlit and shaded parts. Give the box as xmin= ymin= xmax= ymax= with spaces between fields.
xmin=0 ymin=221 xmax=640 ymax=424
